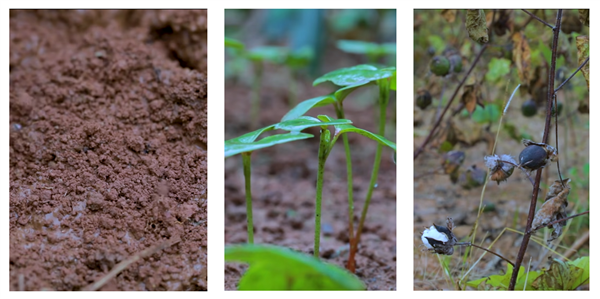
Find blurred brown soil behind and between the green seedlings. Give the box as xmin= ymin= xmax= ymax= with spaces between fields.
xmin=225 ymin=63 xmax=396 ymax=290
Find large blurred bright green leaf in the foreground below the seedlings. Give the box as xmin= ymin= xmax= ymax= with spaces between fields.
xmin=225 ymin=245 xmax=365 ymax=290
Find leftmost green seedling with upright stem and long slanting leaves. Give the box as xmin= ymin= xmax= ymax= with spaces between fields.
xmin=225 ymin=116 xmax=351 ymax=244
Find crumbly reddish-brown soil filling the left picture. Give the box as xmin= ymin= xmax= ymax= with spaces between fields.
xmin=10 ymin=10 xmax=207 ymax=290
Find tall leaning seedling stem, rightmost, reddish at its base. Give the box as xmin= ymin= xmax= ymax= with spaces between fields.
xmin=350 ymin=79 xmax=390 ymax=253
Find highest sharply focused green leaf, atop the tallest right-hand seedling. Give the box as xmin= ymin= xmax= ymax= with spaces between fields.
xmin=313 ymin=64 xmax=396 ymax=86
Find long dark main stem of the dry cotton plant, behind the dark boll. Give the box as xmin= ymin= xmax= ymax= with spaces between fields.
xmin=508 ymin=9 xmax=562 ymax=291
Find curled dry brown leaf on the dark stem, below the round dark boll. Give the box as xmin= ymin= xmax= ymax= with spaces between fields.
xmin=531 ymin=179 xmax=571 ymax=241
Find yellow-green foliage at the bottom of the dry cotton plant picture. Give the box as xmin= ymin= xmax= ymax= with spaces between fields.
xmin=467 ymin=257 xmax=590 ymax=291
